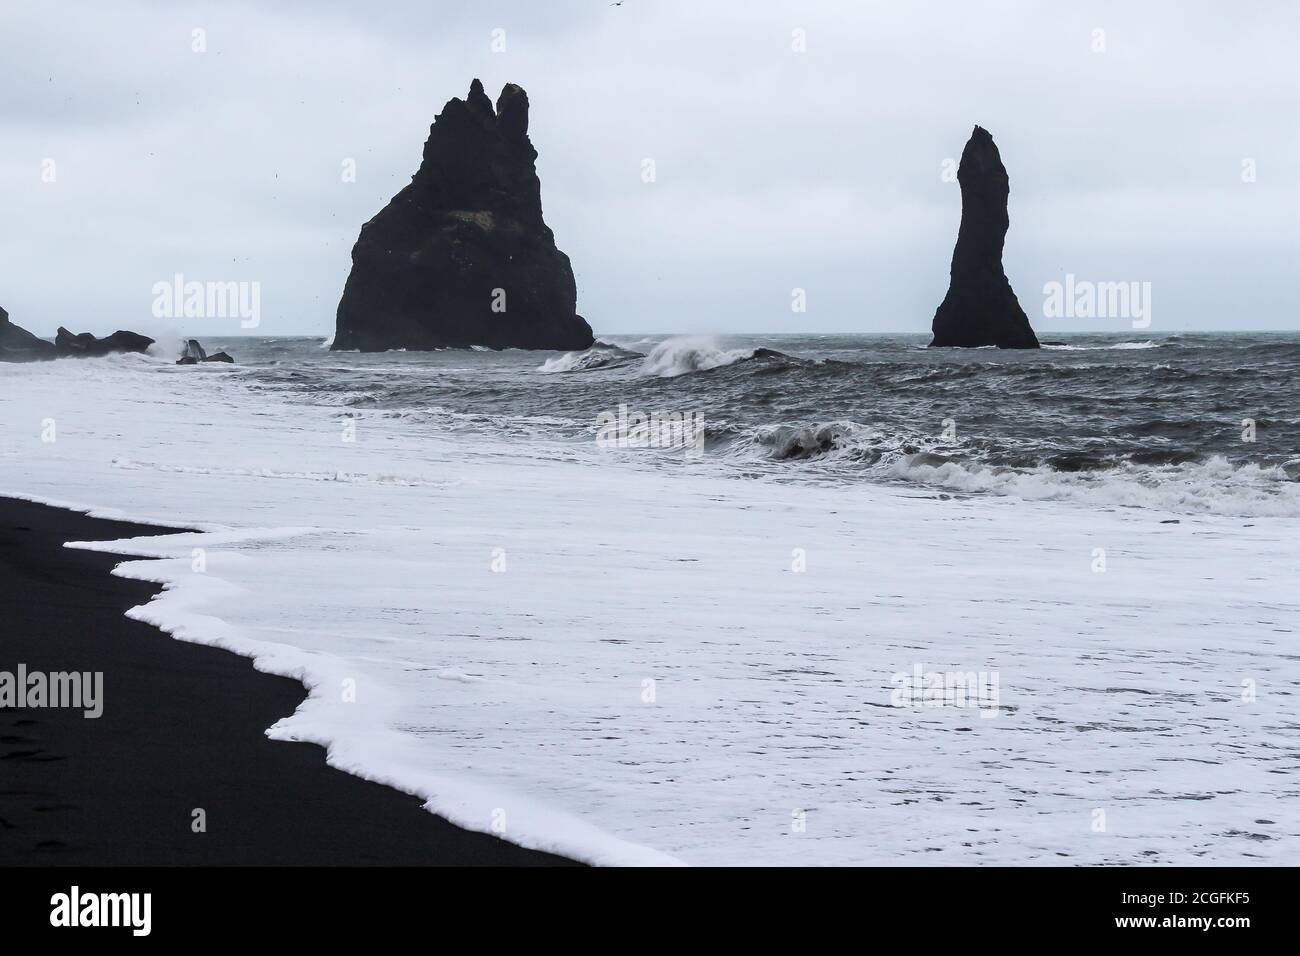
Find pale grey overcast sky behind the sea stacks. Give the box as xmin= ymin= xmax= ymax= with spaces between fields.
xmin=0 ymin=0 xmax=1300 ymax=337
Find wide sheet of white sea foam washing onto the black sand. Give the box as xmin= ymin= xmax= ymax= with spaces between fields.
xmin=0 ymin=362 xmax=1300 ymax=865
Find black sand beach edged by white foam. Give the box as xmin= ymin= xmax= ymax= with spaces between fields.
xmin=0 ymin=498 xmax=568 ymax=866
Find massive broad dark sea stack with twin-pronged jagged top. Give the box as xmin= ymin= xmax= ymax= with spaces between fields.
xmin=330 ymin=79 xmax=594 ymax=351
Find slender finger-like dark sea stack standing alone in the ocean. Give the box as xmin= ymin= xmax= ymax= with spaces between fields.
xmin=930 ymin=126 xmax=1039 ymax=349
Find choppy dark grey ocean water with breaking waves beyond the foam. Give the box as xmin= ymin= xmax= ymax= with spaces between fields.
xmin=212 ymin=333 xmax=1300 ymax=515
